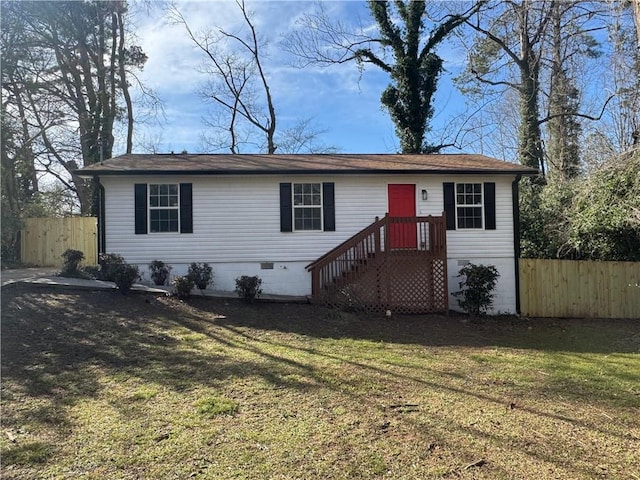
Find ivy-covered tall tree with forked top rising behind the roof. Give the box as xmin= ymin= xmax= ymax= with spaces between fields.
xmin=285 ymin=0 xmax=482 ymax=153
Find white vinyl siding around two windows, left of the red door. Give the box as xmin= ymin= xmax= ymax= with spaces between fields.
xmin=101 ymin=176 xmax=386 ymax=263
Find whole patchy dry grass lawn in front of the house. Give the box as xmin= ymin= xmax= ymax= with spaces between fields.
xmin=0 ymin=286 xmax=640 ymax=480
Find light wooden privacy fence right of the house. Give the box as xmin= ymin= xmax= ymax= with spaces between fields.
xmin=520 ymin=258 xmax=640 ymax=319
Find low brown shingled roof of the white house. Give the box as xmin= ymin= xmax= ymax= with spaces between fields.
xmin=76 ymin=154 xmax=538 ymax=177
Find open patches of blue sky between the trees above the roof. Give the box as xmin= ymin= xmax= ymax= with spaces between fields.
xmin=125 ymin=0 xmax=472 ymax=153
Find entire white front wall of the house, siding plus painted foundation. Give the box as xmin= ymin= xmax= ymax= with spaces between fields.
xmin=101 ymin=175 xmax=515 ymax=312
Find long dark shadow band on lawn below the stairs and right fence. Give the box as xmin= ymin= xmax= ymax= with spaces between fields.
xmin=200 ymin=292 xmax=640 ymax=354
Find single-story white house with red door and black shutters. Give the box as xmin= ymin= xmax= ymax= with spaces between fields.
xmin=77 ymin=154 xmax=537 ymax=313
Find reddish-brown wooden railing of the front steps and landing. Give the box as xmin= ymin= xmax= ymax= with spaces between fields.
xmin=307 ymin=213 xmax=446 ymax=299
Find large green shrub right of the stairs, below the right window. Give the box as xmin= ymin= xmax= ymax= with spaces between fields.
xmin=452 ymin=263 xmax=500 ymax=318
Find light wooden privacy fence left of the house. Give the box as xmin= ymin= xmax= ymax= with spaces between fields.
xmin=20 ymin=217 xmax=98 ymax=267
